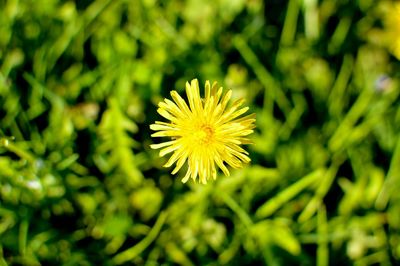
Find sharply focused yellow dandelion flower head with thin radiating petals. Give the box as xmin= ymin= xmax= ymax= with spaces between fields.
xmin=150 ymin=79 xmax=255 ymax=184
